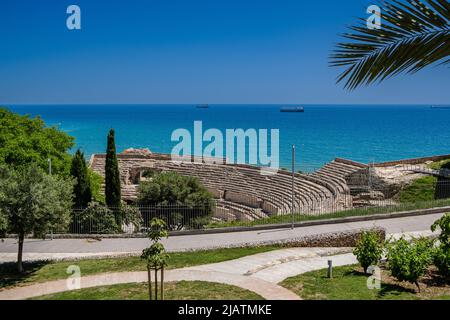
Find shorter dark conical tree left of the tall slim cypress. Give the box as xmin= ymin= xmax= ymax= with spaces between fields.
xmin=70 ymin=150 xmax=92 ymax=208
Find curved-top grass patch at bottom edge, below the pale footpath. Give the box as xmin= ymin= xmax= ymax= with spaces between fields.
xmin=31 ymin=281 xmax=263 ymax=300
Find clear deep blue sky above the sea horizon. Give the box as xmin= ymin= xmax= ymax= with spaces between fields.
xmin=0 ymin=0 xmax=450 ymax=104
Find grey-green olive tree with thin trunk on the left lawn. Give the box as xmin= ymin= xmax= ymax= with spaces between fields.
xmin=0 ymin=164 xmax=73 ymax=272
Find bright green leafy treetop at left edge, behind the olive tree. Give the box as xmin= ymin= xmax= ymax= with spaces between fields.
xmin=0 ymin=108 xmax=73 ymax=175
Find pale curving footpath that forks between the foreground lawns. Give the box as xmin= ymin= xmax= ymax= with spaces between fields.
xmin=0 ymin=248 xmax=356 ymax=300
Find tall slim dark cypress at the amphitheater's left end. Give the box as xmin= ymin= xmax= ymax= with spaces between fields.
xmin=105 ymin=129 xmax=120 ymax=207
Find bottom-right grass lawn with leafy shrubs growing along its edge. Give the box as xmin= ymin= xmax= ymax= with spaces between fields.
xmin=281 ymin=265 xmax=450 ymax=300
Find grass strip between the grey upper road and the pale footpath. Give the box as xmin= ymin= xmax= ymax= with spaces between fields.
xmin=0 ymin=246 xmax=281 ymax=289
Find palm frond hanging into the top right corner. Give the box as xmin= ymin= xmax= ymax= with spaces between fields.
xmin=330 ymin=0 xmax=450 ymax=89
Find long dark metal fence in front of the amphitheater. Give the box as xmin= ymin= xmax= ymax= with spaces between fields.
xmin=54 ymin=177 xmax=450 ymax=234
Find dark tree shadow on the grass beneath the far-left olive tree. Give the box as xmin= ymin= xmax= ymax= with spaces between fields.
xmin=0 ymin=261 xmax=49 ymax=288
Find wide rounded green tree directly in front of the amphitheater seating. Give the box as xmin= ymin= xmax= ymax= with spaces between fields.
xmin=138 ymin=172 xmax=213 ymax=230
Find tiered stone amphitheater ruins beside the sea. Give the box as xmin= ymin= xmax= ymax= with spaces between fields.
xmin=90 ymin=149 xmax=450 ymax=221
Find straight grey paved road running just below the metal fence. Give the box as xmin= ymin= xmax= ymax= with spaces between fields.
xmin=0 ymin=214 xmax=443 ymax=262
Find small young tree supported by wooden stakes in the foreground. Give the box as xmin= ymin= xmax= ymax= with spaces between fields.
xmin=141 ymin=218 xmax=169 ymax=300
